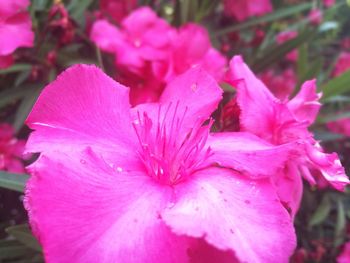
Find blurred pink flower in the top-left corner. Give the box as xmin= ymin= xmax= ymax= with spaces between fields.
xmin=0 ymin=0 xmax=34 ymax=68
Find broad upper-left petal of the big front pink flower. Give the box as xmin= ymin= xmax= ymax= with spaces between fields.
xmin=26 ymin=65 xmax=138 ymax=170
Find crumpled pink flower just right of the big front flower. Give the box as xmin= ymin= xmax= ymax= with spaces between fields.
xmin=229 ymin=56 xmax=349 ymax=217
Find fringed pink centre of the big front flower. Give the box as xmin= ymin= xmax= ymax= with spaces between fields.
xmin=133 ymin=102 xmax=212 ymax=185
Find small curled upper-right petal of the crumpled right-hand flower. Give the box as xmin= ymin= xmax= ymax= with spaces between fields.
xmin=287 ymin=80 xmax=321 ymax=124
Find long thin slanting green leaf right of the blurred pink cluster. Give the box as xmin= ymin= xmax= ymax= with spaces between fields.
xmin=213 ymin=3 xmax=312 ymax=36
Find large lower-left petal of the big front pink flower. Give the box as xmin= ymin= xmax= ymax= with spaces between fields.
xmin=25 ymin=150 xmax=193 ymax=263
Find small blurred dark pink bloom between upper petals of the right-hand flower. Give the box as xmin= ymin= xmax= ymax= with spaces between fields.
xmin=260 ymin=68 xmax=297 ymax=101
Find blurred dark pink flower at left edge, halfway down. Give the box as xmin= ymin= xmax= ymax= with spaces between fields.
xmin=0 ymin=123 xmax=25 ymax=173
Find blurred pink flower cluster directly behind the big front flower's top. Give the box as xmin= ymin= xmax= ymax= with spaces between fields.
xmin=91 ymin=7 xmax=226 ymax=105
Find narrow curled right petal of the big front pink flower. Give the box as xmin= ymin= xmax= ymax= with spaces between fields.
xmin=207 ymin=132 xmax=295 ymax=178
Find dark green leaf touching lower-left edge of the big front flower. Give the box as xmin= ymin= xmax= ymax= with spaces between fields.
xmin=6 ymin=224 xmax=42 ymax=252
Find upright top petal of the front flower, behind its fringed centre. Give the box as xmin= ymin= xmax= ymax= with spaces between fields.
xmin=132 ymin=67 xmax=222 ymax=140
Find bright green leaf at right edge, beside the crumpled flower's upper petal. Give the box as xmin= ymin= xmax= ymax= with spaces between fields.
xmin=321 ymin=70 xmax=350 ymax=100
